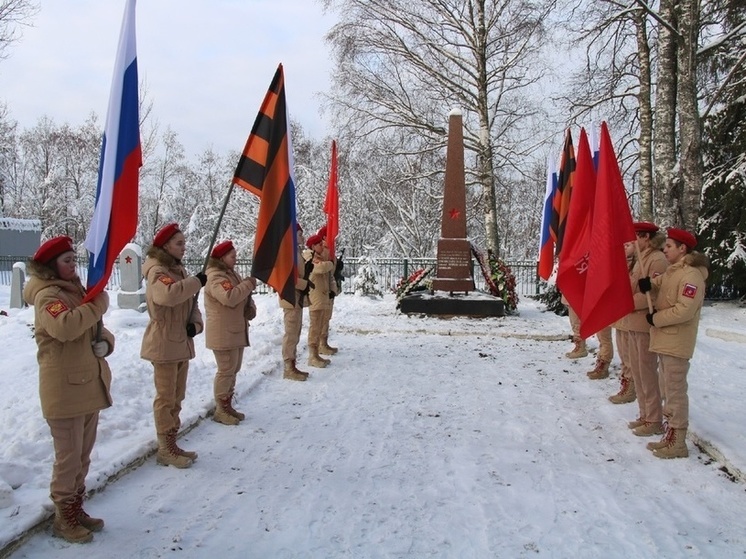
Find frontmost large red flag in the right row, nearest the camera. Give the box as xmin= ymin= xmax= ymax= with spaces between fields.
xmin=579 ymin=122 xmax=635 ymax=338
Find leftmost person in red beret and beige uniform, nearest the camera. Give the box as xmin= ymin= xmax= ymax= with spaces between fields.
xmin=23 ymin=236 xmax=114 ymax=543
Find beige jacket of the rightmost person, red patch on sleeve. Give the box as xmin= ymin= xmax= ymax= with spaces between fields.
xmin=650 ymin=252 xmax=708 ymax=359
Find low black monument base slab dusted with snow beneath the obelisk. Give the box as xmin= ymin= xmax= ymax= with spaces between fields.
xmin=399 ymin=291 xmax=505 ymax=317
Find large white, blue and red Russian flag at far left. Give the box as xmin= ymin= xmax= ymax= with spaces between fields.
xmin=84 ymin=0 xmax=142 ymax=302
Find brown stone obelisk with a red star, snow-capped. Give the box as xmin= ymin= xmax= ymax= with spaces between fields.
xmin=433 ymin=109 xmax=474 ymax=293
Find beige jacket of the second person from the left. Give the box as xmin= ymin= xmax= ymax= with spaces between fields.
xmin=140 ymin=247 xmax=203 ymax=363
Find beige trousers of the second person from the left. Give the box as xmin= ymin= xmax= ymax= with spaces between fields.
xmin=153 ymin=361 xmax=189 ymax=435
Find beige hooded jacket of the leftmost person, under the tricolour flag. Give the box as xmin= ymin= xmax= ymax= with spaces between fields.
xmin=23 ymin=263 xmax=114 ymax=419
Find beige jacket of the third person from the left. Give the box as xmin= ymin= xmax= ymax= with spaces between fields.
xmin=204 ymin=258 xmax=256 ymax=350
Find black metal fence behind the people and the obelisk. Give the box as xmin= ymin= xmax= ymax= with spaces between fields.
xmin=0 ymin=256 xmax=539 ymax=296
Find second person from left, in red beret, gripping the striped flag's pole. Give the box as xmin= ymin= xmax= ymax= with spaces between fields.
xmin=140 ymin=223 xmax=207 ymax=468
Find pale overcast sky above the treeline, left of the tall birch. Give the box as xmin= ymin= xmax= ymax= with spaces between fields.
xmin=0 ymin=0 xmax=334 ymax=156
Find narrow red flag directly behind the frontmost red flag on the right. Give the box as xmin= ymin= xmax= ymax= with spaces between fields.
xmin=557 ymin=128 xmax=596 ymax=316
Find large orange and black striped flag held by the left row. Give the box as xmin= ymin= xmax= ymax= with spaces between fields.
xmin=233 ymin=64 xmax=298 ymax=304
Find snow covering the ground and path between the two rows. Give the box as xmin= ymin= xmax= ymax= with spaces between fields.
xmin=0 ymin=287 xmax=746 ymax=559
